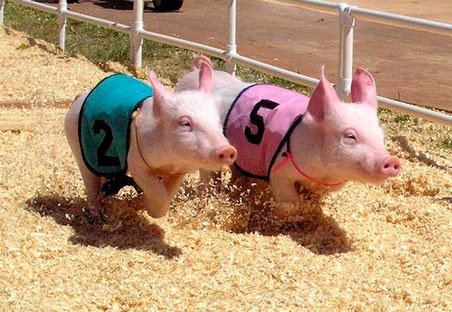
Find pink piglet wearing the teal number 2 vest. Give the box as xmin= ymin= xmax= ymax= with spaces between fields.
xmin=65 ymin=65 xmax=237 ymax=217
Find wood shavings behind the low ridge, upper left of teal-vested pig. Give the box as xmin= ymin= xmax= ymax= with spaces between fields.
xmin=0 ymin=29 xmax=123 ymax=106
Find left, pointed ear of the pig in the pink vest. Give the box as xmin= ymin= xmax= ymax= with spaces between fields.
xmin=308 ymin=65 xmax=340 ymax=121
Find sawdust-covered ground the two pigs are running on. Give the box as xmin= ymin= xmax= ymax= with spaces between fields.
xmin=0 ymin=29 xmax=452 ymax=311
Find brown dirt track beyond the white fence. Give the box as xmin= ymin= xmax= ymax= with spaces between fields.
xmin=61 ymin=0 xmax=452 ymax=110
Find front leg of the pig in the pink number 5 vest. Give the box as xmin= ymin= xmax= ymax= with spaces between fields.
xmin=270 ymin=172 xmax=300 ymax=218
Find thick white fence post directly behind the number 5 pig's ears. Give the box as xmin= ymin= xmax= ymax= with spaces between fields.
xmin=336 ymin=3 xmax=356 ymax=100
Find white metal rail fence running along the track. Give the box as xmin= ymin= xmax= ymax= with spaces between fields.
xmin=0 ymin=0 xmax=452 ymax=126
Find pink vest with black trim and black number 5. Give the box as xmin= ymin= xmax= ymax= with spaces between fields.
xmin=224 ymin=84 xmax=309 ymax=180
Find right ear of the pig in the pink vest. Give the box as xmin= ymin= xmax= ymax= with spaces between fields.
xmin=351 ymin=68 xmax=377 ymax=108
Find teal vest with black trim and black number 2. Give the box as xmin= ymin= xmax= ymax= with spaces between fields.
xmin=78 ymin=74 xmax=153 ymax=177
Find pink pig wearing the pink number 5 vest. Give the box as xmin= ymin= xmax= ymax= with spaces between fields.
xmin=176 ymin=56 xmax=400 ymax=216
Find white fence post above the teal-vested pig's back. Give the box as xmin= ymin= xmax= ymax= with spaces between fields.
xmin=129 ymin=0 xmax=144 ymax=69
